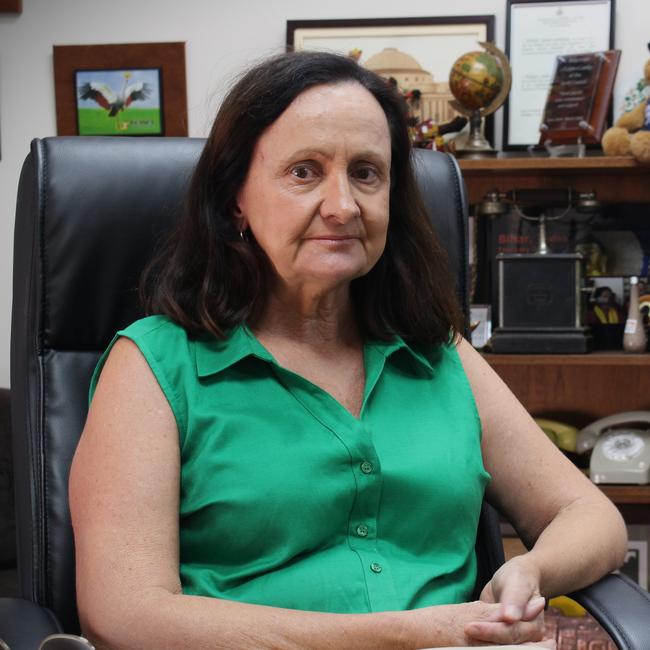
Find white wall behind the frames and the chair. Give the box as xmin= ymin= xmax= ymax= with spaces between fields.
xmin=0 ymin=0 xmax=650 ymax=386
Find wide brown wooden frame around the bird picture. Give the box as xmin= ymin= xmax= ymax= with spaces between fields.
xmin=54 ymin=42 xmax=188 ymax=136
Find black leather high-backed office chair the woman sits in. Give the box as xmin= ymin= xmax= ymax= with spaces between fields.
xmin=0 ymin=137 xmax=650 ymax=650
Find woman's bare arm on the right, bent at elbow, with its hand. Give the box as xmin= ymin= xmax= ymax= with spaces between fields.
xmin=458 ymin=340 xmax=627 ymax=636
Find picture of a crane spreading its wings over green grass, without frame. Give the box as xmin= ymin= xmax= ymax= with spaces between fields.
xmin=75 ymin=68 xmax=165 ymax=135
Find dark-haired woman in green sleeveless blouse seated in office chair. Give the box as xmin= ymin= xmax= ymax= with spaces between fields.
xmin=70 ymin=53 xmax=625 ymax=649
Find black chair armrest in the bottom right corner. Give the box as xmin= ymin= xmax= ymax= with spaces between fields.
xmin=569 ymin=573 xmax=650 ymax=650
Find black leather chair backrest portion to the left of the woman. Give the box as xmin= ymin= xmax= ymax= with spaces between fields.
xmin=11 ymin=138 xmax=203 ymax=630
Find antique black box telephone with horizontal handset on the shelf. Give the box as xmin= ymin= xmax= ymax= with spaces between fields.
xmin=478 ymin=188 xmax=600 ymax=354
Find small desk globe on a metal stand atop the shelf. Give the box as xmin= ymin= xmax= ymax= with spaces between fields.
xmin=449 ymin=42 xmax=512 ymax=158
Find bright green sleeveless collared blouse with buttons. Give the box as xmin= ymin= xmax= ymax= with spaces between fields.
xmin=91 ymin=316 xmax=490 ymax=613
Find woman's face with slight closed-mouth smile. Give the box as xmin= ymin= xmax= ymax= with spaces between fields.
xmin=237 ymin=82 xmax=391 ymax=289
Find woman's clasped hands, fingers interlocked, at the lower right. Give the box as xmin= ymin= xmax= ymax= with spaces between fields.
xmin=465 ymin=556 xmax=545 ymax=644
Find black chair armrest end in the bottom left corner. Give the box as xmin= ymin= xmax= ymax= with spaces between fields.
xmin=0 ymin=598 xmax=63 ymax=650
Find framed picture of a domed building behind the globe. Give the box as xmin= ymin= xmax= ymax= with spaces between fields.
xmin=287 ymin=16 xmax=494 ymax=141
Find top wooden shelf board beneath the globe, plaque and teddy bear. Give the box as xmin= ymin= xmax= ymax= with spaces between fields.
xmin=459 ymin=156 xmax=650 ymax=203
